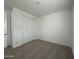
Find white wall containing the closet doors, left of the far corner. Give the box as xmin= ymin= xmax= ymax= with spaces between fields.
xmin=11 ymin=8 xmax=36 ymax=48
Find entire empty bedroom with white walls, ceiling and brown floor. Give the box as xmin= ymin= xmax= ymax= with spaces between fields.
xmin=4 ymin=0 xmax=74 ymax=59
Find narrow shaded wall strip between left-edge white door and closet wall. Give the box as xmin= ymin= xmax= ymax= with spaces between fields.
xmin=4 ymin=9 xmax=11 ymax=46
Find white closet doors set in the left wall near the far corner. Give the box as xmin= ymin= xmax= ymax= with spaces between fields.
xmin=22 ymin=16 xmax=33 ymax=43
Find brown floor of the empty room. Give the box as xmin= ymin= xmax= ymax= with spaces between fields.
xmin=4 ymin=39 xmax=74 ymax=59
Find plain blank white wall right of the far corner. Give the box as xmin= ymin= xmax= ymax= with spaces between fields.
xmin=39 ymin=9 xmax=72 ymax=46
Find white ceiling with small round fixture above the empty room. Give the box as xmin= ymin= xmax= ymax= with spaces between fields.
xmin=4 ymin=0 xmax=73 ymax=17
